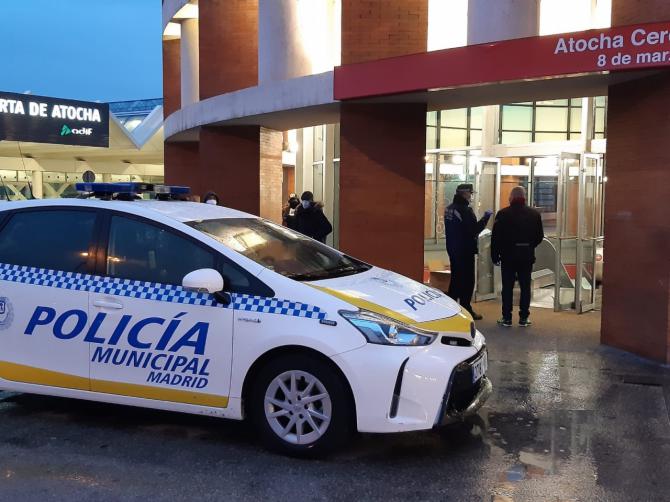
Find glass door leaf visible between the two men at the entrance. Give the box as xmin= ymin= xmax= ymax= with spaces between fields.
xmin=473 ymin=158 xmax=500 ymax=301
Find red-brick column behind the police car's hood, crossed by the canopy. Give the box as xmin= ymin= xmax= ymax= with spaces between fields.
xmin=339 ymin=0 xmax=428 ymax=281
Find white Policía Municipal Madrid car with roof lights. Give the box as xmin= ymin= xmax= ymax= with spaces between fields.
xmin=0 ymin=184 xmax=491 ymax=455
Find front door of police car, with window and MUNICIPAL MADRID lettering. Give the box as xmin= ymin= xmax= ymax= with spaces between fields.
xmin=90 ymin=211 xmax=233 ymax=408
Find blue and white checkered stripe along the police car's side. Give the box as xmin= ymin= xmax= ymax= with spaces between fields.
xmin=0 ymin=263 xmax=326 ymax=319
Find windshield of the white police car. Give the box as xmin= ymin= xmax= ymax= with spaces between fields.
xmin=186 ymin=218 xmax=371 ymax=281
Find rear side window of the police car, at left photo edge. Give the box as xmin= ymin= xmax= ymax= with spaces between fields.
xmin=0 ymin=210 xmax=96 ymax=273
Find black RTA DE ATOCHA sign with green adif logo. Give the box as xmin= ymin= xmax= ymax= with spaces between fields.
xmin=0 ymin=92 xmax=109 ymax=148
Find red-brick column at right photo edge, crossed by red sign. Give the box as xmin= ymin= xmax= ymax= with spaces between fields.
xmin=600 ymin=0 xmax=670 ymax=363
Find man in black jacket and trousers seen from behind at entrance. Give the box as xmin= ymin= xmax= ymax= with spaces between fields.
xmin=491 ymin=186 xmax=544 ymax=326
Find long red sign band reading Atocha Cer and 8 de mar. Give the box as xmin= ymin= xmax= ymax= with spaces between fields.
xmin=334 ymin=21 xmax=670 ymax=100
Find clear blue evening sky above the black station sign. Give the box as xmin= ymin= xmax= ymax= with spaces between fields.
xmin=0 ymin=0 xmax=163 ymax=102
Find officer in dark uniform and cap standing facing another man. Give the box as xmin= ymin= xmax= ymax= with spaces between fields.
xmin=444 ymin=183 xmax=493 ymax=320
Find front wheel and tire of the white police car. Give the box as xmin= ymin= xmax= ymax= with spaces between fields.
xmin=249 ymin=354 xmax=354 ymax=457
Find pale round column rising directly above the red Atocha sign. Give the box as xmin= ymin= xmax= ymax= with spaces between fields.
xmin=468 ymin=0 xmax=540 ymax=44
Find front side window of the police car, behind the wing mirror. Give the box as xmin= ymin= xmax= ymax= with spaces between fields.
xmin=107 ymin=216 xmax=216 ymax=285
